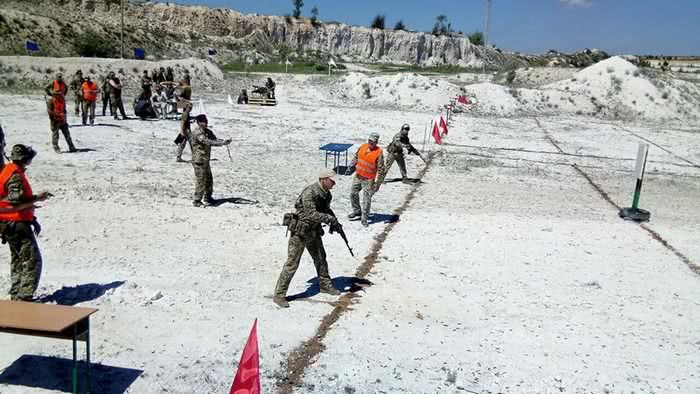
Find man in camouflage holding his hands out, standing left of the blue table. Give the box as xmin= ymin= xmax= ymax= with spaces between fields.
xmin=192 ymin=114 xmax=231 ymax=207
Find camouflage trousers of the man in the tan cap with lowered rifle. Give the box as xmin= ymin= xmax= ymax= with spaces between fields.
xmin=275 ymin=233 xmax=333 ymax=297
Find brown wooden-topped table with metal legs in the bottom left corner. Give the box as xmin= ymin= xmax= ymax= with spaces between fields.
xmin=0 ymin=300 xmax=97 ymax=393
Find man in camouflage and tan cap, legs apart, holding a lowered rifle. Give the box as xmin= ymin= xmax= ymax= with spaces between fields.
xmin=273 ymin=169 xmax=340 ymax=308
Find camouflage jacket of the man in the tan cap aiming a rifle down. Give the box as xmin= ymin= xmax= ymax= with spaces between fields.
xmin=294 ymin=182 xmax=335 ymax=233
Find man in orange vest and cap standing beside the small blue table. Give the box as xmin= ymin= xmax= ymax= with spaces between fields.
xmin=348 ymin=133 xmax=384 ymax=227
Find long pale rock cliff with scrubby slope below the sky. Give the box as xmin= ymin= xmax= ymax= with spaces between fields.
xmin=0 ymin=0 xmax=525 ymax=67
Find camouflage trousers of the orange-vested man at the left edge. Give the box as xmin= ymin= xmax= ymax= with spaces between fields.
xmin=0 ymin=222 xmax=42 ymax=300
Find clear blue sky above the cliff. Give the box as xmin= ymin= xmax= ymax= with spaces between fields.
xmin=156 ymin=0 xmax=700 ymax=56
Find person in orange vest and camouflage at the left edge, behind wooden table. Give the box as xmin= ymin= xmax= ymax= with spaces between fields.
xmin=0 ymin=144 xmax=52 ymax=301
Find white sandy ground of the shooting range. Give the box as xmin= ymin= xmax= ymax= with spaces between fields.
xmin=0 ymin=63 xmax=700 ymax=393
